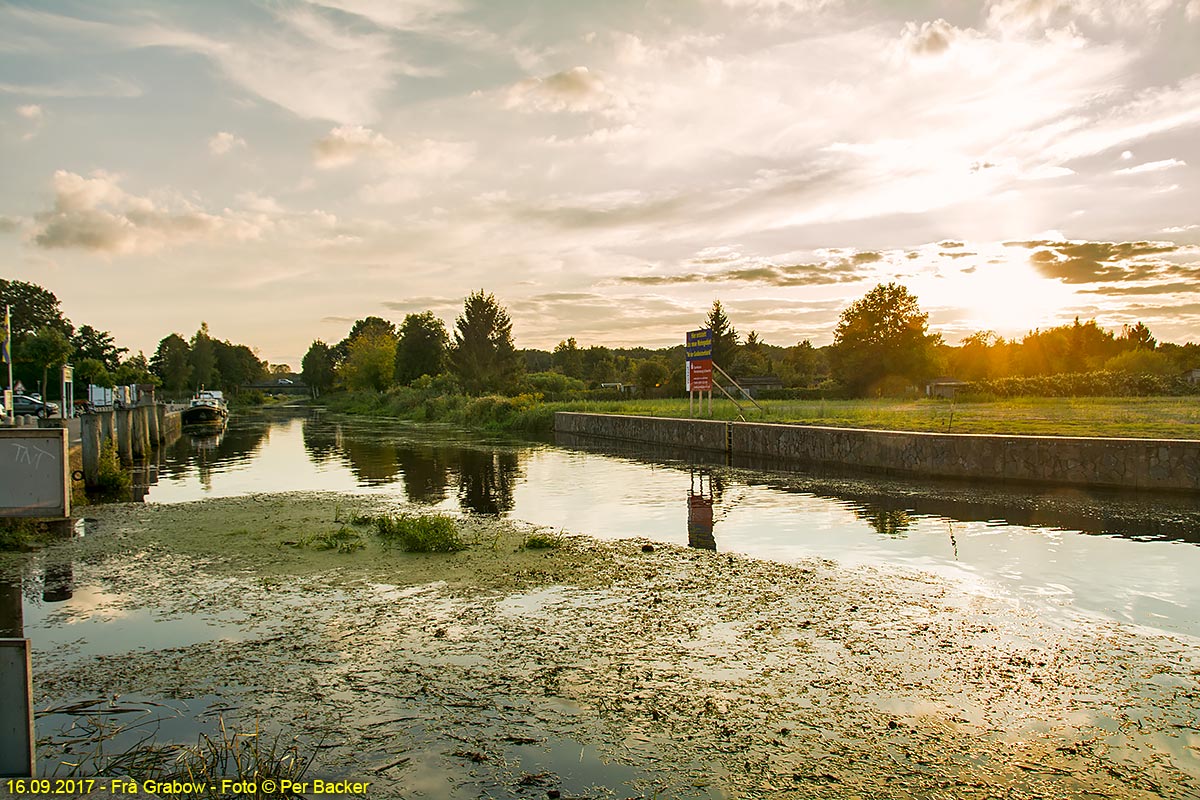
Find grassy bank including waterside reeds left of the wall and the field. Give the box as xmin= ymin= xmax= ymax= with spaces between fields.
xmin=320 ymin=389 xmax=1200 ymax=439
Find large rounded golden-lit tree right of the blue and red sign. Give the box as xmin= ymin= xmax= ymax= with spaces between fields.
xmin=830 ymin=283 xmax=941 ymax=395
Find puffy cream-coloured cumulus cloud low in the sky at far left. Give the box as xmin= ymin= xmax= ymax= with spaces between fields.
xmin=32 ymin=170 xmax=259 ymax=253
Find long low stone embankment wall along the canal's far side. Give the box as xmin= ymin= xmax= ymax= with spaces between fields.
xmin=554 ymin=413 xmax=1200 ymax=492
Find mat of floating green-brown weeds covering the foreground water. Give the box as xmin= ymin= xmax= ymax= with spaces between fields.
xmin=0 ymin=494 xmax=1200 ymax=798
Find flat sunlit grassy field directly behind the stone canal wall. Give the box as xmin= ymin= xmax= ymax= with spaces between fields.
xmin=548 ymin=397 xmax=1200 ymax=439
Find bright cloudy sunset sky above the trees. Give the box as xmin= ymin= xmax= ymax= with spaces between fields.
xmin=0 ymin=0 xmax=1200 ymax=367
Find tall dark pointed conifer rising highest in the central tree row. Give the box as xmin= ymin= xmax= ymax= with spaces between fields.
xmin=450 ymin=289 xmax=523 ymax=395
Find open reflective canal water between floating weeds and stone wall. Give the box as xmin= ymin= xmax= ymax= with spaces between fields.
xmin=129 ymin=402 xmax=1200 ymax=637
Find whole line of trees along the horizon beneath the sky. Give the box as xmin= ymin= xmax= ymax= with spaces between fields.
xmin=0 ymin=281 xmax=1200 ymax=397
